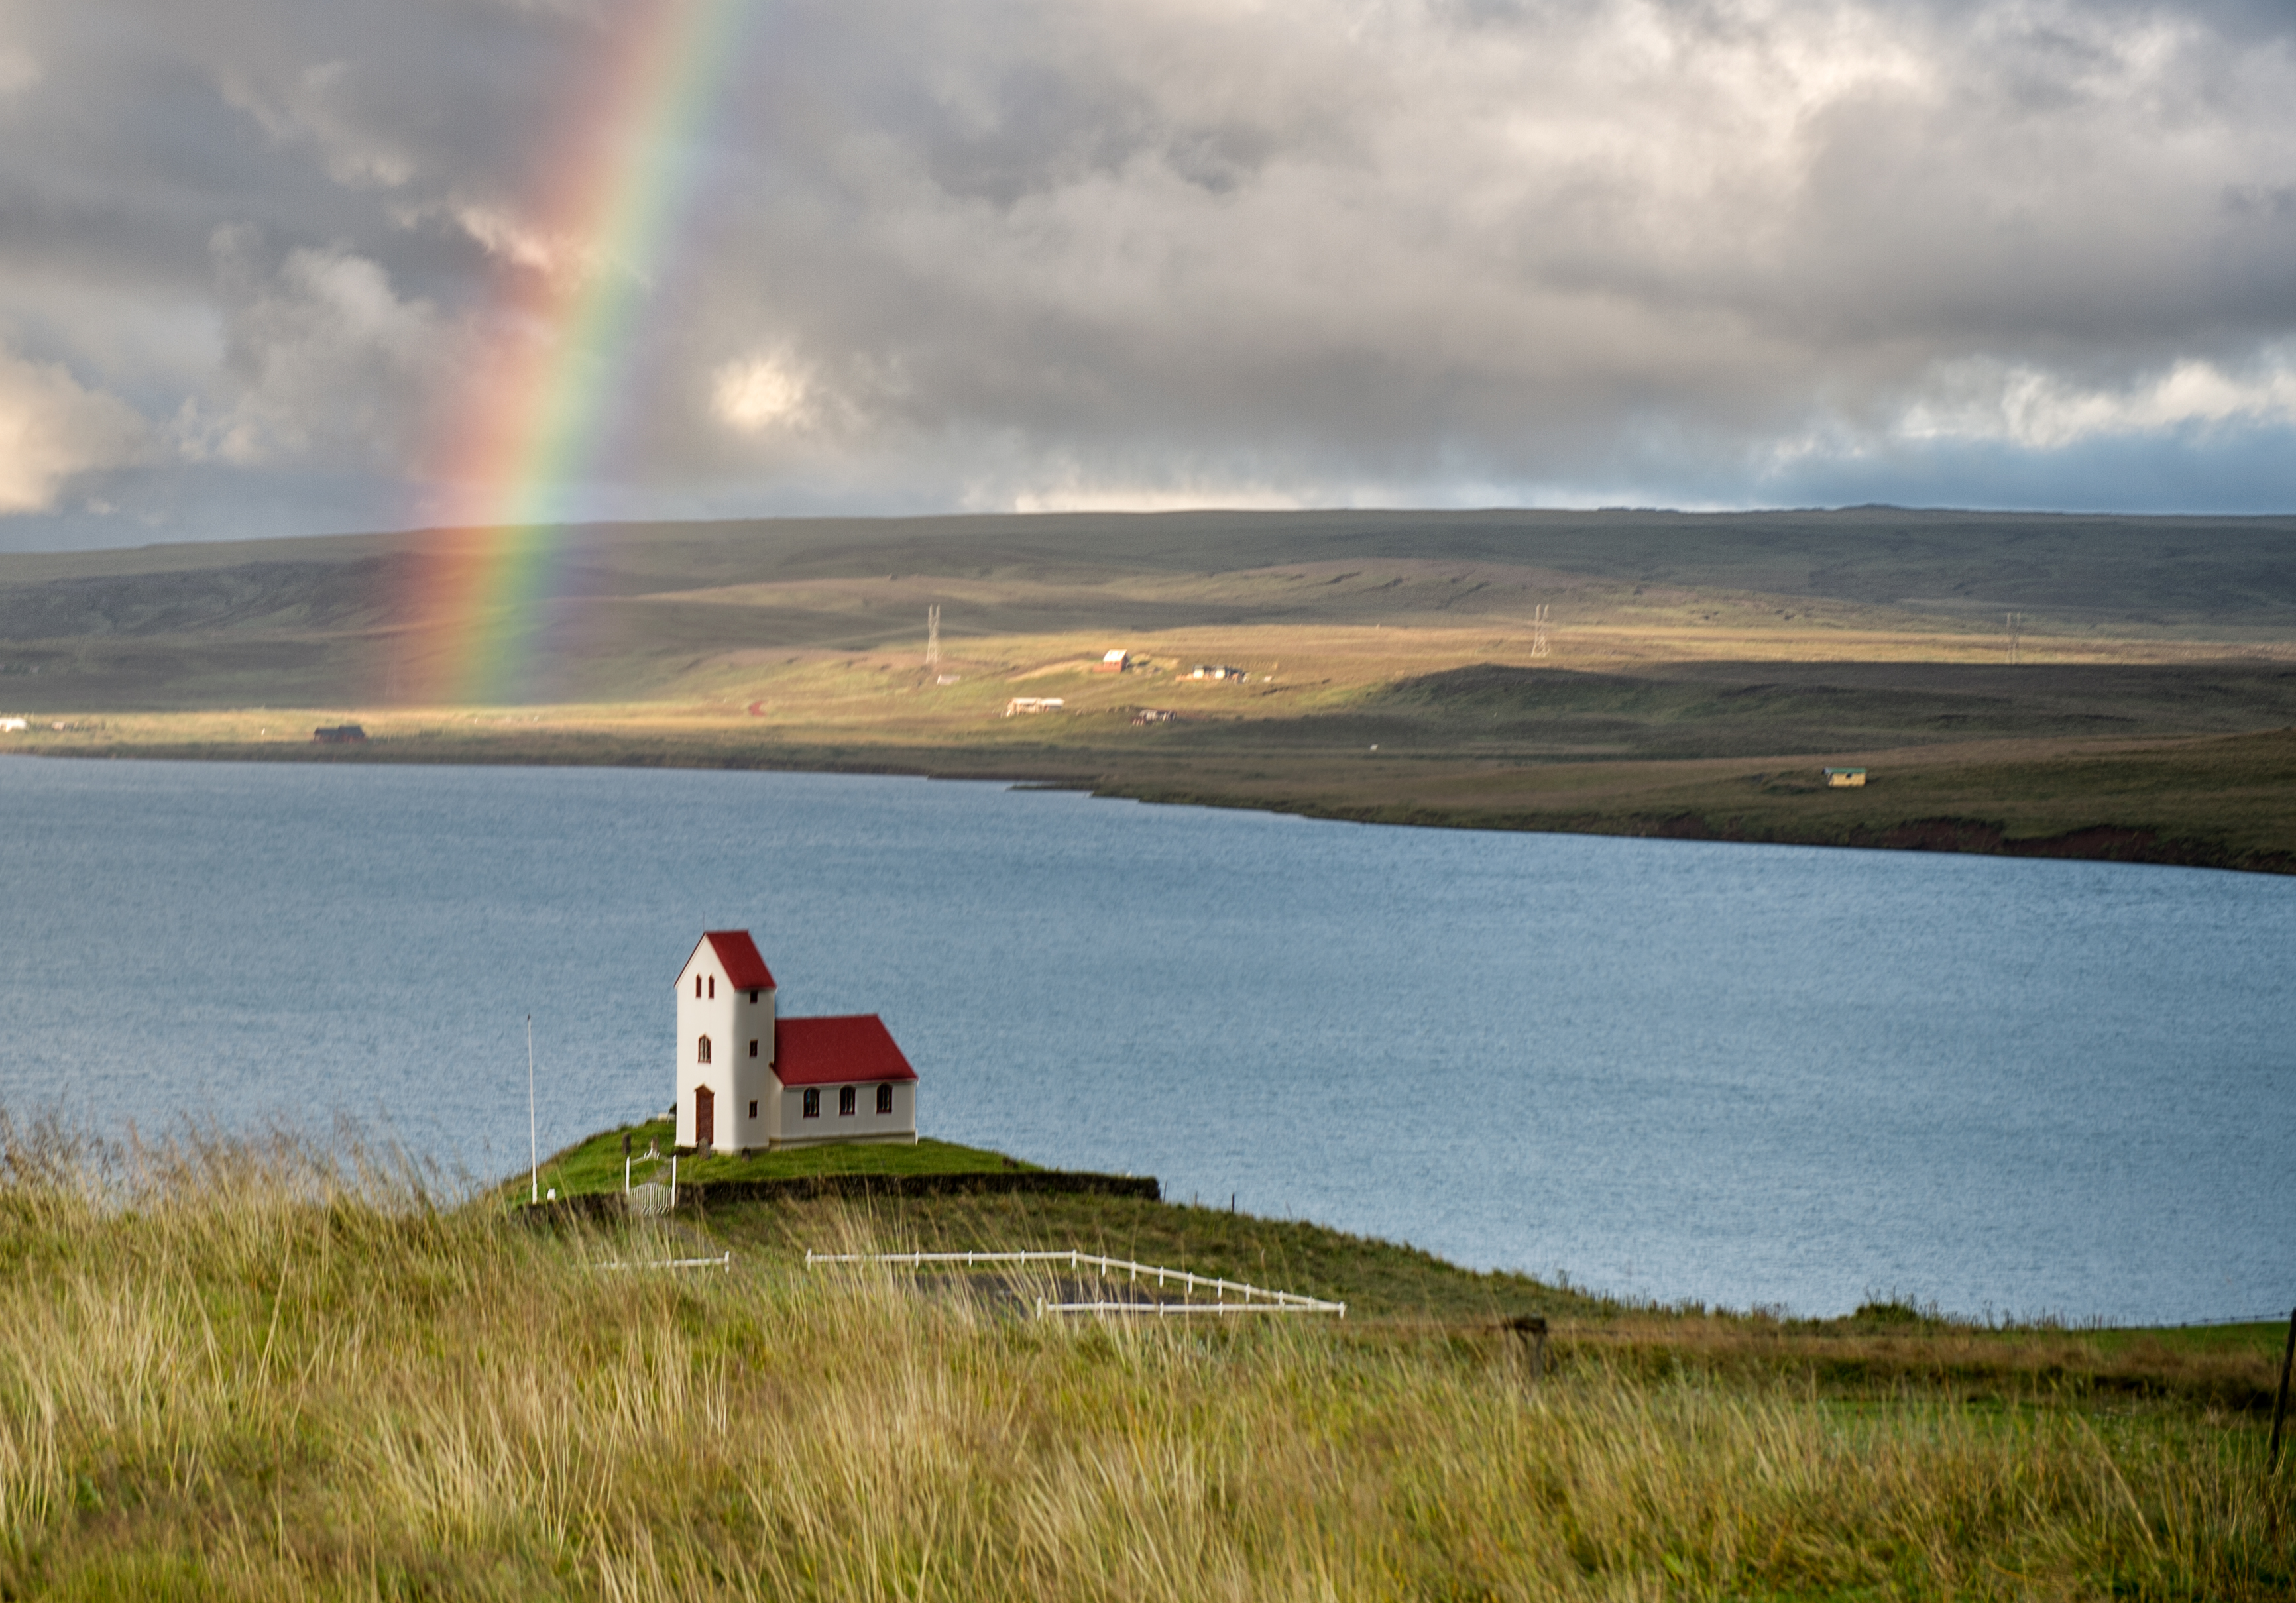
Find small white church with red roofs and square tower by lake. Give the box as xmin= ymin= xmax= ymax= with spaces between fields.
xmin=677 ymin=930 xmax=916 ymax=1153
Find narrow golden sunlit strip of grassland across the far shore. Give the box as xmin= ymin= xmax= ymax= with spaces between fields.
xmin=18 ymin=620 xmax=2296 ymax=758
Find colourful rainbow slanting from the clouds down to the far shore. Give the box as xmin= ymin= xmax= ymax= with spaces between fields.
xmin=404 ymin=0 xmax=758 ymax=702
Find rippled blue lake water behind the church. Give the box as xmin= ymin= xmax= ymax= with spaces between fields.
xmin=0 ymin=758 xmax=2296 ymax=1321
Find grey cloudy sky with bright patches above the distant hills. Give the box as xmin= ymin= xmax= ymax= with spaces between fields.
xmin=0 ymin=0 xmax=2296 ymax=549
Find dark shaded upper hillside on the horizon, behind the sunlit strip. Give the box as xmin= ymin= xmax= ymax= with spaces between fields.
xmin=13 ymin=508 xmax=2296 ymax=712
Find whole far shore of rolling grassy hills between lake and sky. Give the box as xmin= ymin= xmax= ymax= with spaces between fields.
xmin=0 ymin=510 xmax=2296 ymax=873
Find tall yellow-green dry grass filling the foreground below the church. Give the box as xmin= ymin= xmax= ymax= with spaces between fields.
xmin=0 ymin=1125 xmax=2296 ymax=1601
